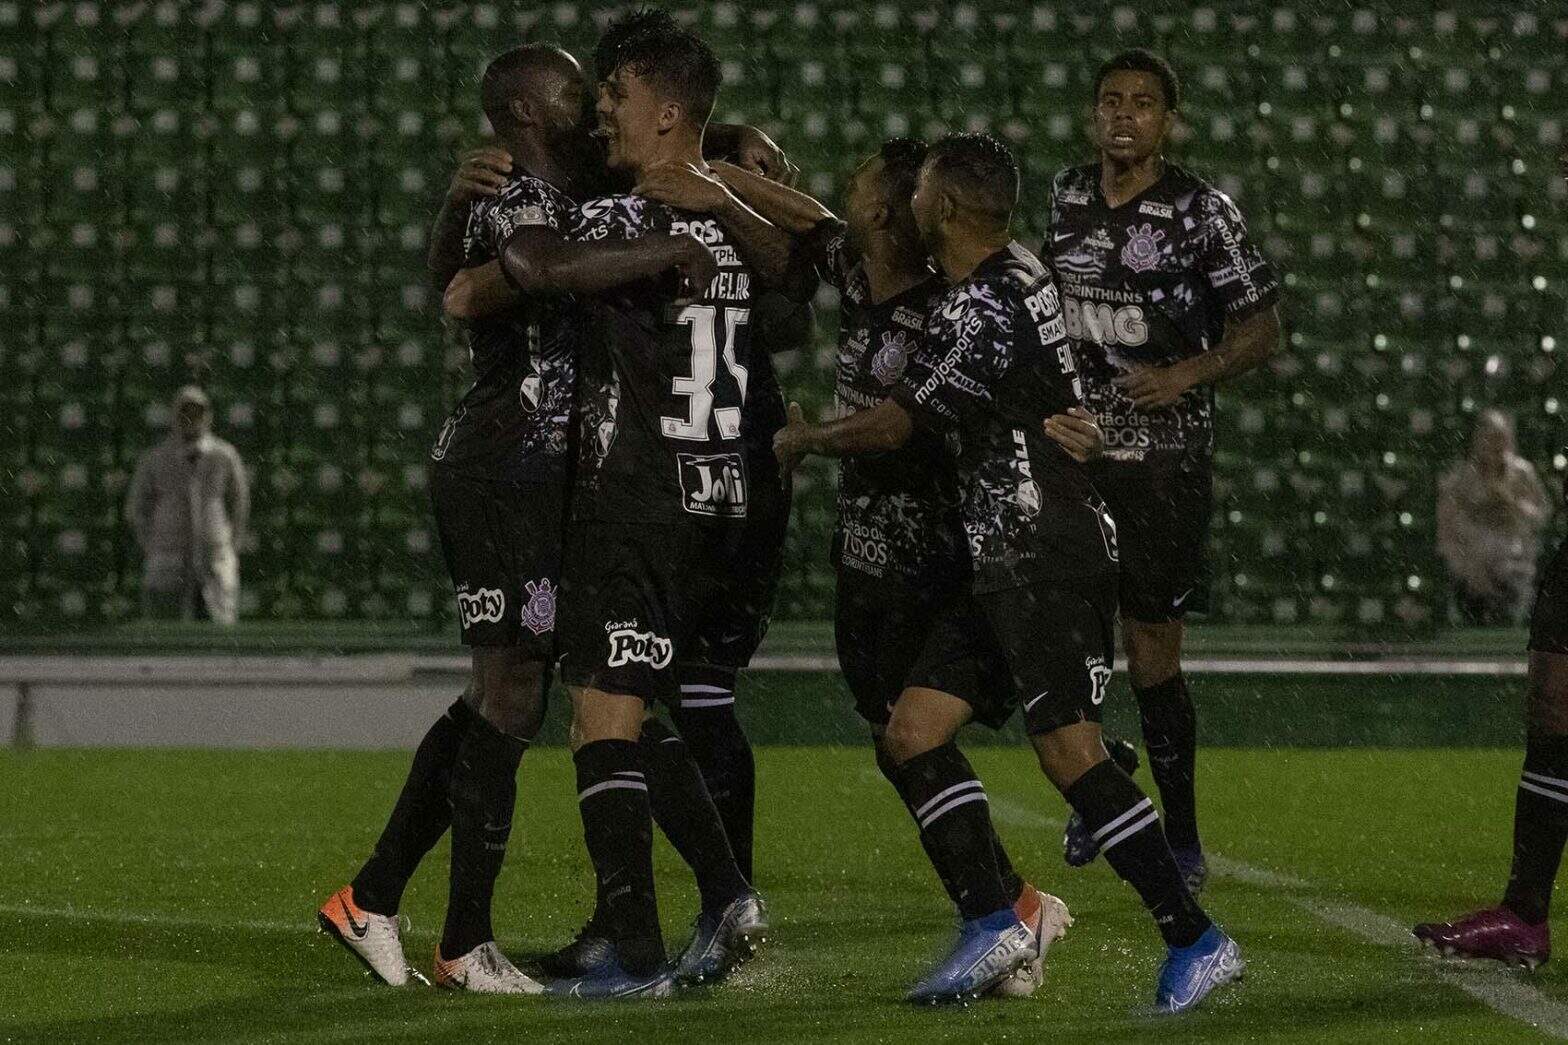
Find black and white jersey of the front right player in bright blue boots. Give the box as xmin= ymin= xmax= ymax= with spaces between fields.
xmin=892 ymin=242 xmax=1116 ymax=593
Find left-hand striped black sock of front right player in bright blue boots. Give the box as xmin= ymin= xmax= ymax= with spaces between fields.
xmin=898 ymin=742 xmax=1018 ymax=921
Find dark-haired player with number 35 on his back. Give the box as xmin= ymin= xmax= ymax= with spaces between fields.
xmin=533 ymin=16 xmax=789 ymax=998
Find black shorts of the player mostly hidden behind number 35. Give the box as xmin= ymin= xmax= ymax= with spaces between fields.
xmin=681 ymin=463 xmax=790 ymax=672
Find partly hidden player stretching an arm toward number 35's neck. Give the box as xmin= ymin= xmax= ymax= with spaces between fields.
xmin=717 ymin=138 xmax=1087 ymax=993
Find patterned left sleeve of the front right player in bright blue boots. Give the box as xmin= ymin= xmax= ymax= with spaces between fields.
xmin=892 ymin=284 xmax=1014 ymax=433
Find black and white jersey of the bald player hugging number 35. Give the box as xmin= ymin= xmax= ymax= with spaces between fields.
xmin=430 ymin=174 xmax=580 ymax=483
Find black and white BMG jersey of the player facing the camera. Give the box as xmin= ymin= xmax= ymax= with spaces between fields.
xmin=1041 ymin=163 xmax=1279 ymax=468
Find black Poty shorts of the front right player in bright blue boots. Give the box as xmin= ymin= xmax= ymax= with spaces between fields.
xmin=908 ymin=576 xmax=1116 ymax=736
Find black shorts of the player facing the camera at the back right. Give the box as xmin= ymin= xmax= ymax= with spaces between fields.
xmin=1093 ymin=461 xmax=1214 ymax=624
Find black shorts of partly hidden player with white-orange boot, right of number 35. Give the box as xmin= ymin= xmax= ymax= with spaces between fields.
xmin=833 ymin=568 xmax=961 ymax=726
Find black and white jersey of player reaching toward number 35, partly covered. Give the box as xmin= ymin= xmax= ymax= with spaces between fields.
xmin=803 ymin=220 xmax=964 ymax=579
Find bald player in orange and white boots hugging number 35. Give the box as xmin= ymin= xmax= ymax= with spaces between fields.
xmin=318 ymin=46 xmax=727 ymax=993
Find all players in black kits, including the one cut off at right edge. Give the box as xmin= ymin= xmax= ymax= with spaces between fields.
xmin=318 ymin=4 xmax=1568 ymax=1012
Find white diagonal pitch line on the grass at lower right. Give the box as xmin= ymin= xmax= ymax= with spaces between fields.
xmin=991 ymin=796 xmax=1568 ymax=1040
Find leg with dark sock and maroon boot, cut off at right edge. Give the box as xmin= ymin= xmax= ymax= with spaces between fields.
xmin=1414 ymin=149 xmax=1568 ymax=968
